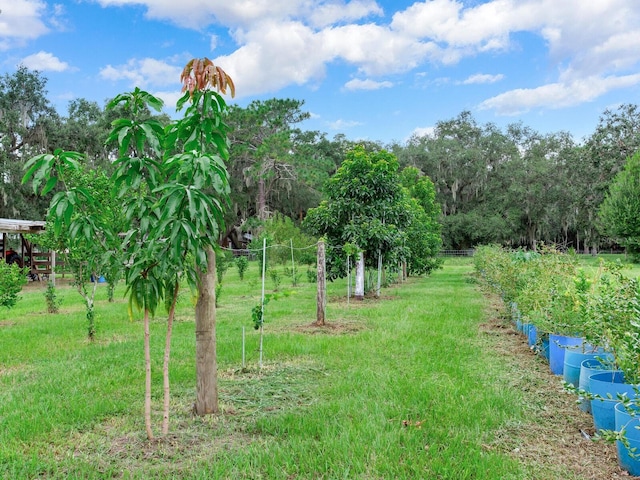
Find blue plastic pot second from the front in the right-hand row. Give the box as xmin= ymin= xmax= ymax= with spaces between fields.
xmin=589 ymin=371 xmax=636 ymax=431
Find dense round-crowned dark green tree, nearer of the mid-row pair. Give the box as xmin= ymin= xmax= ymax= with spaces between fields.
xmin=303 ymin=147 xmax=435 ymax=286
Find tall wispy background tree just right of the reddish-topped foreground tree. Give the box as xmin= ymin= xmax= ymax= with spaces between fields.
xmin=226 ymin=98 xmax=330 ymax=224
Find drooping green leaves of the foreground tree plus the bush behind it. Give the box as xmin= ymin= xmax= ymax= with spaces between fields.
xmin=23 ymin=83 xmax=229 ymax=322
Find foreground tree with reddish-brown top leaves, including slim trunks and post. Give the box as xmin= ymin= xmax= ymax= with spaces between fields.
xmin=23 ymin=58 xmax=235 ymax=438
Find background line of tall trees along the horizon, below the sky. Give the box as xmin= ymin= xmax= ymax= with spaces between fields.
xmin=0 ymin=67 xmax=640 ymax=255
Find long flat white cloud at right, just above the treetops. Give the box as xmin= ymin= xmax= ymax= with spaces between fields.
xmin=479 ymin=74 xmax=640 ymax=115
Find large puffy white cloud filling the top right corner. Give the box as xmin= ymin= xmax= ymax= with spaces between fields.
xmin=391 ymin=0 xmax=640 ymax=75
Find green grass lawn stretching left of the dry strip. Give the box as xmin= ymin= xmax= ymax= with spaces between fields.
xmin=0 ymin=259 xmax=632 ymax=480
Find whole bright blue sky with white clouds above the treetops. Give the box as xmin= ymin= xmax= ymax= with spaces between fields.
xmin=0 ymin=0 xmax=640 ymax=143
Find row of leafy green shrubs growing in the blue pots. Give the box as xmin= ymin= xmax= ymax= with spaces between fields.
xmin=474 ymin=242 xmax=640 ymax=384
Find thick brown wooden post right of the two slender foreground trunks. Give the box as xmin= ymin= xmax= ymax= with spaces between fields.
xmin=195 ymin=248 xmax=218 ymax=415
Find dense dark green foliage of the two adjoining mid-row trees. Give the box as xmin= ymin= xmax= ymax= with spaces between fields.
xmin=303 ymin=147 xmax=441 ymax=280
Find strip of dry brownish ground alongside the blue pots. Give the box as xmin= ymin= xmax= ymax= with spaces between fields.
xmin=480 ymin=301 xmax=640 ymax=480
